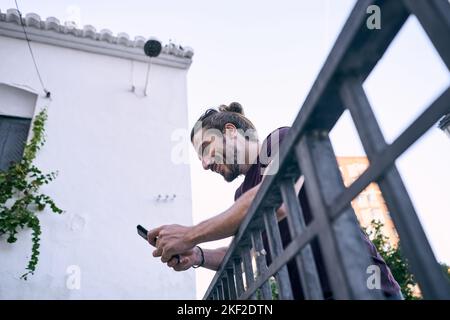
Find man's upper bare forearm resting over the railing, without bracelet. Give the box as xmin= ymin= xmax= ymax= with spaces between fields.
xmin=188 ymin=184 xmax=260 ymax=245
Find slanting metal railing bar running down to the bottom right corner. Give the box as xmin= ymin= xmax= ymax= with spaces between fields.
xmin=341 ymin=78 xmax=450 ymax=299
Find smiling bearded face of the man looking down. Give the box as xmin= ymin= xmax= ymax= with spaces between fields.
xmin=192 ymin=129 xmax=240 ymax=182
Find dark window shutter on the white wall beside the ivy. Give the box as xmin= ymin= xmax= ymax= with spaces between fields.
xmin=0 ymin=116 xmax=31 ymax=171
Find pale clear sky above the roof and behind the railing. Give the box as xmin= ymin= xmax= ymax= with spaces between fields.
xmin=0 ymin=0 xmax=450 ymax=298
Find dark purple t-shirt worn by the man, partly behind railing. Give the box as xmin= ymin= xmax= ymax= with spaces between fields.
xmin=234 ymin=127 xmax=400 ymax=299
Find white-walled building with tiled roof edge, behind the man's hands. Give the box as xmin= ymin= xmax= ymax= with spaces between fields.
xmin=0 ymin=9 xmax=195 ymax=299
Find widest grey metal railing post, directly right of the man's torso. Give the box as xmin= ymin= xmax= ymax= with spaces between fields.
xmin=296 ymin=131 xmax=382 ymax=299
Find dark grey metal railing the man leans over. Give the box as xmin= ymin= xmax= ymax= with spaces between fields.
xmin=204 ymin=0 xmax=450 ymax=299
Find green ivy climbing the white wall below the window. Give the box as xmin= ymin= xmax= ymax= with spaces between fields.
xmin=0 ymin=108 xmax=63 ymax=280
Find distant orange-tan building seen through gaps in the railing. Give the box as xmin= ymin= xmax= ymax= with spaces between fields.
xmin=337 ymin=157 xmax=399 ymax=246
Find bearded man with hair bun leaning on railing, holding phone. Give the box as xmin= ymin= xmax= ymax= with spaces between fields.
xmin=148 ymin=102 xmax=401 ymax=299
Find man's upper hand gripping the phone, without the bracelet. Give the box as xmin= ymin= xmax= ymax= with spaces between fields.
xmin=147 ymin=224 xmax=195 ymax=263
